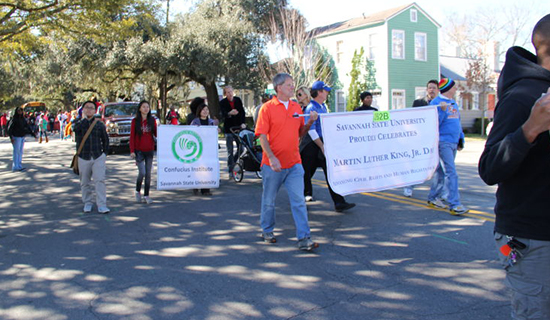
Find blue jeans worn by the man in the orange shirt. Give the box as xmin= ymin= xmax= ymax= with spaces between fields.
xmin=260 ymin=163 xmax=310 ymax=240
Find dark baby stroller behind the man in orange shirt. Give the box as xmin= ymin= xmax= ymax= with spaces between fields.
xmin=229 ymin=127 xmax=262 ymax=182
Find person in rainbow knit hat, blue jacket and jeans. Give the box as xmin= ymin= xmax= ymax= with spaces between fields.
xmin=428 ymin=78 xmax=469 ymax=215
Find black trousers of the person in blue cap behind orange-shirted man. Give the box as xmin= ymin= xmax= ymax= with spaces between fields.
xmin=300 ymin=141 xmax=346 ymax=205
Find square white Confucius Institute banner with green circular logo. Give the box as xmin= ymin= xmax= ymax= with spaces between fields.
xmin=157 ymin=125 xmax=220 ymax=190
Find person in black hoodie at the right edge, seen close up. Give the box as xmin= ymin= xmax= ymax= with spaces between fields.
xmin=478 ymin=14 xmax=550 ymax=319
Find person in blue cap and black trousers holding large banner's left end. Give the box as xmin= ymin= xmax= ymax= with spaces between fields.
xmin=300 ymin=81 xmax=355 ymax=212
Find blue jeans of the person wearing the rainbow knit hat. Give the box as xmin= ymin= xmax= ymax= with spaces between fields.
xmin=428 ymin=141 xmax=460 ymax=209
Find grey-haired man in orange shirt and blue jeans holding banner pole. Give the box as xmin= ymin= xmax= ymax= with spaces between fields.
xmin=256 ymin=73 xmax=319 ymax=251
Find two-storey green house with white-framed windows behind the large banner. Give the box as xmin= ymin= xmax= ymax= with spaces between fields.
xmin=312 ymin=3 xmax=441 ymax=112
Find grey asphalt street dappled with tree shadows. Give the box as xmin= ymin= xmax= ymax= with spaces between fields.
xmin=0 ymin=134 xmax=510 ymax=320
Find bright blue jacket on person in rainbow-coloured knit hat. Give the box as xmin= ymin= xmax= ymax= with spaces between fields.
xmin=430 ymin=94 xmax=464 ymax=143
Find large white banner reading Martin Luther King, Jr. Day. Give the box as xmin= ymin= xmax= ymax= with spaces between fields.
xmin=321 ymin=107 xmax=439 ymax=195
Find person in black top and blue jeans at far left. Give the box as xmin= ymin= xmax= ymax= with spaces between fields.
xmin=8 ymin=107 xmax=36 ymax=171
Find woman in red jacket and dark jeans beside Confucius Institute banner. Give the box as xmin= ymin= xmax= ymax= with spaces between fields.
xmin=130 ymin=101 xmax=157 ymax=204
